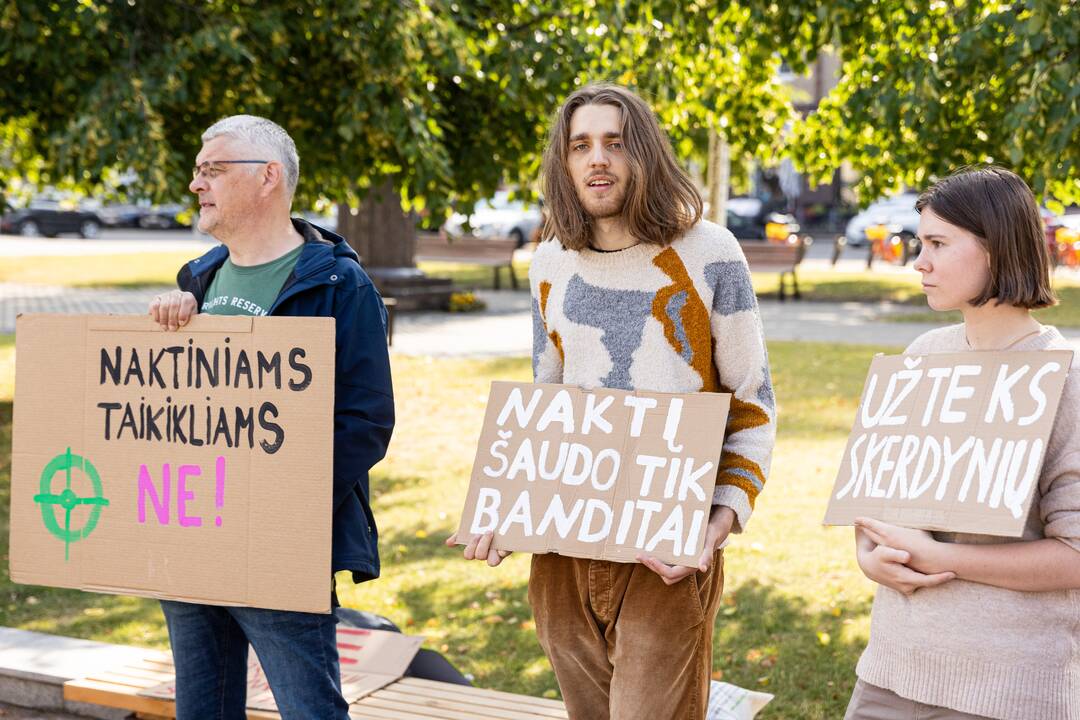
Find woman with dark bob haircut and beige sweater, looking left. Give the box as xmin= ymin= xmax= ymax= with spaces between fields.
xmin=846 ymin=166 xmax=1080 ymax=720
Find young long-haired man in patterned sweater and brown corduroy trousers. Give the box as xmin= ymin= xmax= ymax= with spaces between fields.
xmin=451 ymin=84 xmax=775 ymax=720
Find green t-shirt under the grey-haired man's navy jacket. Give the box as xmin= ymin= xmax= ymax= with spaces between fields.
xmin=200 ymin=245 xmax=303 ymax=315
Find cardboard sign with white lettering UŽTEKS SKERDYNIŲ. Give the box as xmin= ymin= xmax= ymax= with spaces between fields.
xmin=825 ymin=350 xmax=1072 ymax=536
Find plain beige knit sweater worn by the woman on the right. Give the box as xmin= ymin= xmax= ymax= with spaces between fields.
xmin=856 ymin=325 xmax=1080 ymax=720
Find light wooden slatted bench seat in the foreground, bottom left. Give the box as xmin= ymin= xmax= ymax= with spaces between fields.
xmin=64 ymin=651 xmax=567 ymax=720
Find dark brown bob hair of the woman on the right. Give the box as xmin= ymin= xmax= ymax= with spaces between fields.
xmin=915 ymin=165 xmax=1057 ymax=310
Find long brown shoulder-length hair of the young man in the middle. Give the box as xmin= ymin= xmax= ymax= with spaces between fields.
xmin=540 ymin=83 xmax=702 ymax=250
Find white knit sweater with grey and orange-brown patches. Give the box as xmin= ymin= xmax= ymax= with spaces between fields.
xmin=529 ymin=221 xmax=775 ymax=532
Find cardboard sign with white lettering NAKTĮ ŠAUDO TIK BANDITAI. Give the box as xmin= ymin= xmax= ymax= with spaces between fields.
xmin=458 ymin=382 xmax=731 ymax=566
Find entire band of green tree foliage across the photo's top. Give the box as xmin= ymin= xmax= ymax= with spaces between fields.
xmin=0 ymin=0 xmax=1080 ymax=207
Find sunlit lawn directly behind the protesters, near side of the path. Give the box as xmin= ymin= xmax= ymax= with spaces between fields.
xmin=0 ymin=336 xmax=895 ymax=720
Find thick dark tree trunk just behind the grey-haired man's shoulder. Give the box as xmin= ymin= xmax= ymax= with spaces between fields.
xmin=338 ymin=178 xmax=416 ymax=268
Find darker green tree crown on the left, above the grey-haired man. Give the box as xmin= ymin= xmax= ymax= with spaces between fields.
xmin=0 ymin=0 xmax=576 ymax=211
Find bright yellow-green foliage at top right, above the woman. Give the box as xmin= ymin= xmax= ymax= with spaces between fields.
xmin=779 ymin=0 xmax=1080 ymax=203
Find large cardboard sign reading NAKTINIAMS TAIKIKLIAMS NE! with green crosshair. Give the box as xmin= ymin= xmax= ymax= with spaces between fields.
xmin=11 ymin=315 xmax=335 ymax=612
